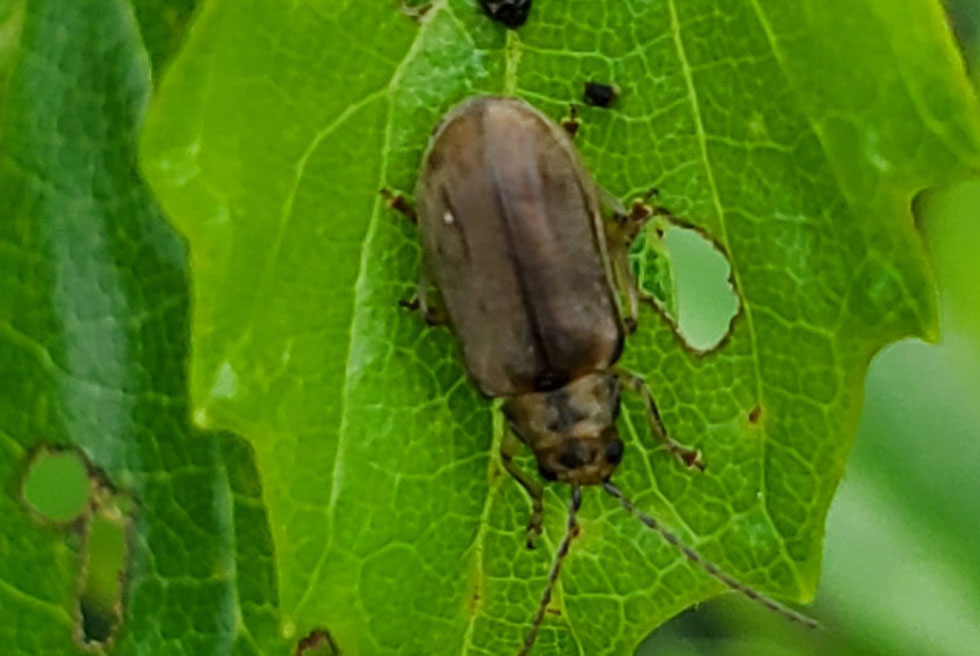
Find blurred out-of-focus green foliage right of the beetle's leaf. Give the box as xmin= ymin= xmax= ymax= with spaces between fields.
xmin=637 ymin=179 xmax=980 ymax=656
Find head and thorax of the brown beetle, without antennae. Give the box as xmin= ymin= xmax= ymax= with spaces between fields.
xmin=504 ymin=371 xmax=623 ymax=485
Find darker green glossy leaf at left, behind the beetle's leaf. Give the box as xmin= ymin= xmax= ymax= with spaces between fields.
xmin=0 ymin=0 xmax=284 ymax=656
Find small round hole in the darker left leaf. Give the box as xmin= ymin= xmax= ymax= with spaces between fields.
xmin=21 ymin=449 xmax=89 ymax=523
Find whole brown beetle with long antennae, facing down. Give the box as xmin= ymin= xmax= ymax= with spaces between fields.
xmin=398 ymin=96 xmax=815 ymax=654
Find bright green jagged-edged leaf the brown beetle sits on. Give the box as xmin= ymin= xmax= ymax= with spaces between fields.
xmin=142 ymin=0 xmax=980 ymax=654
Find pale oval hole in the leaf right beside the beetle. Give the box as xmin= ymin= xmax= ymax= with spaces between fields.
xmin=663 ymin=225 xmax=739 ymax=351
